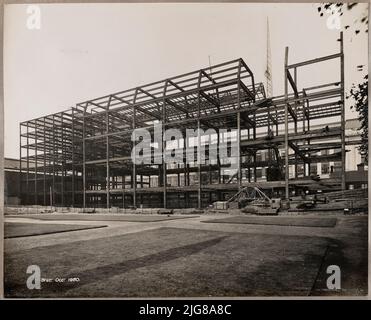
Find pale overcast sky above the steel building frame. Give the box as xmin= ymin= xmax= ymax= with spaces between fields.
xmin=4 ymin=3 xmax=368 ymax=158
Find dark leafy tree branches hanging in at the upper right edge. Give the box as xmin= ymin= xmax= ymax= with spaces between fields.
xmin=317 ymin=3 xmax=368 ymax=163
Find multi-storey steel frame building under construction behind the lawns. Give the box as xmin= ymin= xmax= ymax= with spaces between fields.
xmin=20 ymin=34 xmax=346 ymax=208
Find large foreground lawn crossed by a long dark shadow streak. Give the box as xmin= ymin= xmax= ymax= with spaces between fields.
xmin=5 ymin=228 xmax=356 ymax=297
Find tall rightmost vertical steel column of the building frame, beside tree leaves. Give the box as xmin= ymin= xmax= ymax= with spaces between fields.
xmin=340 ymin=32 xmax=346 ymax=191
